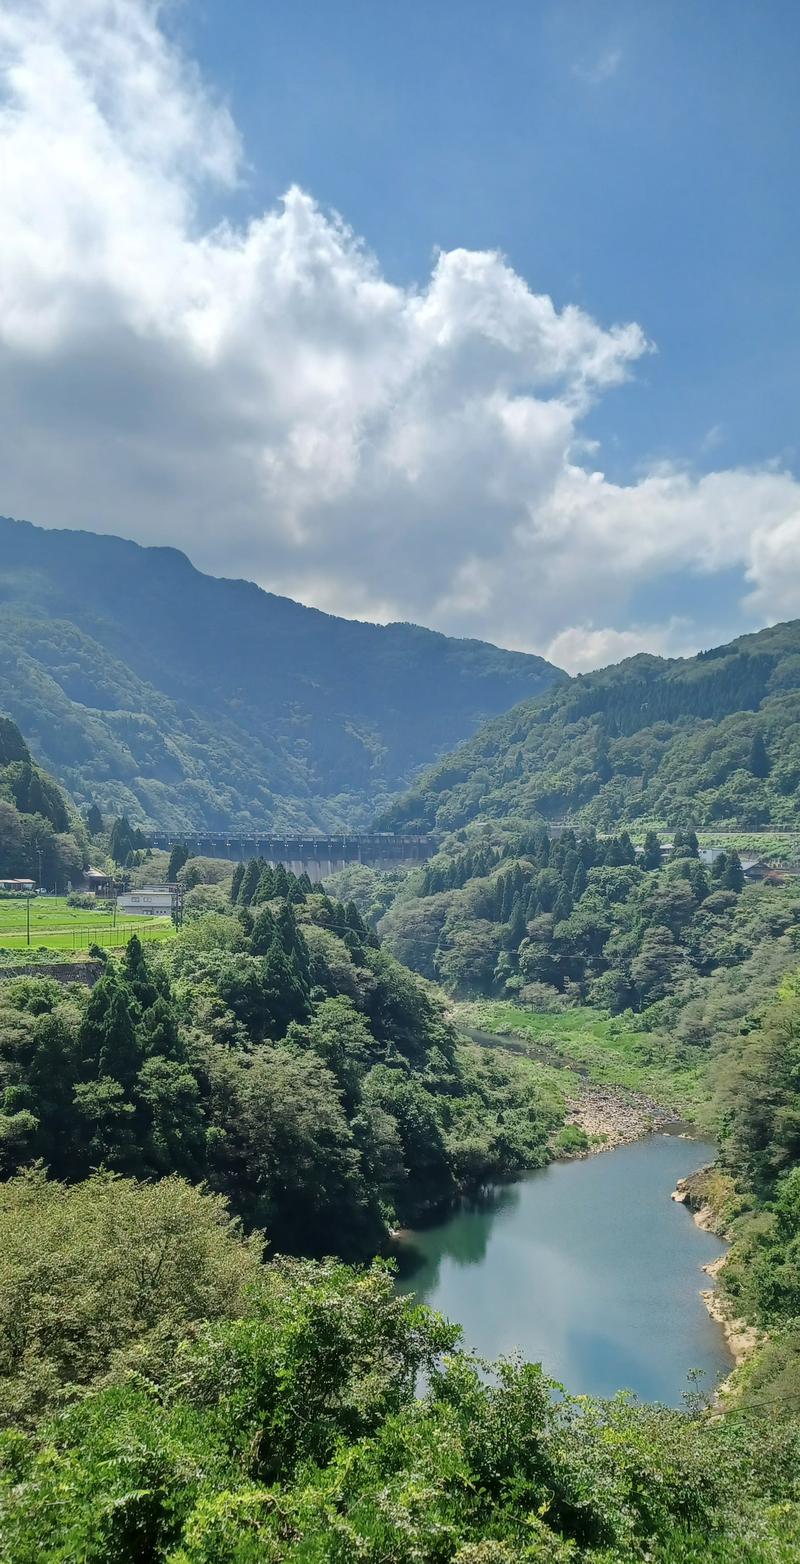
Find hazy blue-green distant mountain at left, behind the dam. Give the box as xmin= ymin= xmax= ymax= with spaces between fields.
xmin=0 ymin=519 xmax=566 ymax=830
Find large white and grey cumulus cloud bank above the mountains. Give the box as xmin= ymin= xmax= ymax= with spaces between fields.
xmin=0 ymin=0 xmax=800 ymax=666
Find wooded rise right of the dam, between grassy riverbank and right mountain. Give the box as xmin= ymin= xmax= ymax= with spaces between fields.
xmin=381 ymin=827 xmax=800 ymax=1024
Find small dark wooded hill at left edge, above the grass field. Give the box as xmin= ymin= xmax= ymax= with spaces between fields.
xmin=0 ymin=715 xmax=86 ymax=887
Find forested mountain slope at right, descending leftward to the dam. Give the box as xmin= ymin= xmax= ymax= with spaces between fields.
xmin=378 ymin=621 xmax=800 ymax=830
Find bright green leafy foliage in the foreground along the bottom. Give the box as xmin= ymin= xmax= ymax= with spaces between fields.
xmin=0 ymin=1219 xmax=800 ymax=1564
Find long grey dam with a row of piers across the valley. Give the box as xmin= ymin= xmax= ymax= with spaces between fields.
xmin=150 ymin=830 xmax=439 ymax=879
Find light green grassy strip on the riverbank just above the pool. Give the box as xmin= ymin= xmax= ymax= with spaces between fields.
xmin=453 ymin=999 xmax=709 ymax=1125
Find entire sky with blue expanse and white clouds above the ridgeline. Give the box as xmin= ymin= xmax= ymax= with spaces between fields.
xmin=0 ymin=0 xmax=800 ymax=668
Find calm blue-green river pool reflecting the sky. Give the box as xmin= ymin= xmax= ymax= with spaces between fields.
xmin=398 ymin=1134 xmax=733 ymax=1406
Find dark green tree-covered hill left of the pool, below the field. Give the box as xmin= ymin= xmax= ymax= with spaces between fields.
xmin=0 ymin=863 xmax=563 ymax=1254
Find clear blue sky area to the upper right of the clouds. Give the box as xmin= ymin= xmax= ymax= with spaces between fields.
xmin=180 ymin=0 xmax=800 ymax=479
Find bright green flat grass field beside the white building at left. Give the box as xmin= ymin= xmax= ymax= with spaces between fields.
xmin=0 ymin=896 xmax=173 ymax=951
